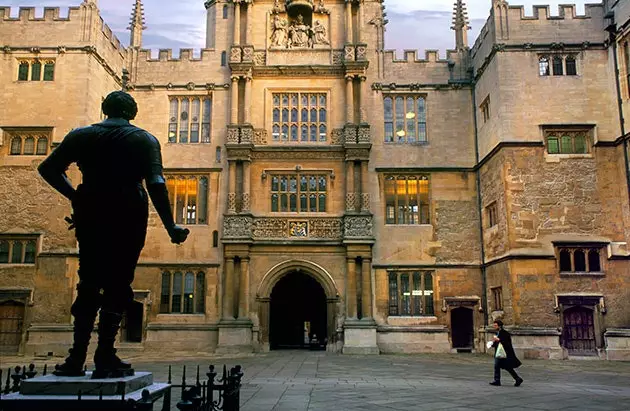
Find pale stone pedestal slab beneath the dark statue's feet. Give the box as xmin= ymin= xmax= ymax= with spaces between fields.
xmin=0 ymin=372 xmax=170 ymax=411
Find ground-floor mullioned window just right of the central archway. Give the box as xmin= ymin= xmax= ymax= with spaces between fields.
xmin=387 ymin=269 xmax=436 ymax=318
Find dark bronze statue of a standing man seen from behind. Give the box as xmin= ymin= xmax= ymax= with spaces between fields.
xmin=38 ymin=91 xmax=189 ymax=378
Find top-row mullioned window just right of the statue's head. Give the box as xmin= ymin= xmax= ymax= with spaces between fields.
xmin=168 ymin=96 xmax=212 ymax=144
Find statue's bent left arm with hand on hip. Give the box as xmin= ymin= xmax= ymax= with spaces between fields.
xmin=37 ymin=128 xmax=78 ymax=201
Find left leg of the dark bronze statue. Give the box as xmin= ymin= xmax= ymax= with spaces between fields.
xmin=53 ymin=243 xmax=102 ymax=377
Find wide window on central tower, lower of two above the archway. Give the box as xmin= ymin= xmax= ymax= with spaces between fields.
xmin=271 ymin=173 xmax=328 ymax=213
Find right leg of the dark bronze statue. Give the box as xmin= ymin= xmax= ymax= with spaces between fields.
xmin=92 ymin=241 xmax=142 ymax=378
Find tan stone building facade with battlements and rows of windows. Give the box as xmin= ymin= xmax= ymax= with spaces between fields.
xmin=0 ymin=0 xmax=630 ymax=359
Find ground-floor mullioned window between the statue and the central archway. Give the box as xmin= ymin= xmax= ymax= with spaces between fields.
xmin=160 ymin=271 xmax=206 ymax=314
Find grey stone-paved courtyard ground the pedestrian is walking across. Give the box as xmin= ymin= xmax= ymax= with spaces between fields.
xmin=2 ymin=351 xmax=630 ymax=411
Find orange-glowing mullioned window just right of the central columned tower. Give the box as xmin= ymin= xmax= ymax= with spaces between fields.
xmin=385 ymin=175 xmax=430 ymax=224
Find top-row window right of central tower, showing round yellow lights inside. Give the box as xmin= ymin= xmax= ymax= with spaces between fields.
xmin=383 ymin=93 xmax=429 ymax=144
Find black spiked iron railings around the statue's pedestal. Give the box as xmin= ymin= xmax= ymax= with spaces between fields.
xmin=0 ymin=364 xmax=243 ymax=411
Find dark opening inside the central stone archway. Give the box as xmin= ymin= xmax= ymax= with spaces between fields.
xmin=269 ymin=271 xmax=328 ymax=350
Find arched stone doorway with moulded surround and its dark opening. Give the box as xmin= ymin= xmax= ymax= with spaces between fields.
xmin=256 ymin=260 xmax=339 ymax=351
